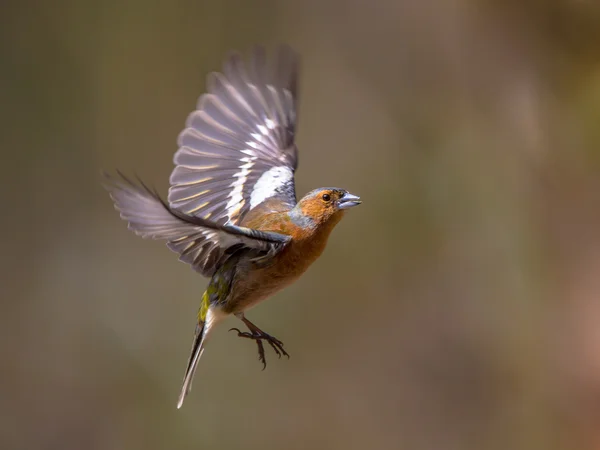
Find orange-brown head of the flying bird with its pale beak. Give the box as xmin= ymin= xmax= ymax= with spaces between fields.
xmin=295 ymin=188 xmax=361 ymax=226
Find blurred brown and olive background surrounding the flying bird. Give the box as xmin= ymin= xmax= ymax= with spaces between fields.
xmin=0 ymin=0 xmax=600 ymax=450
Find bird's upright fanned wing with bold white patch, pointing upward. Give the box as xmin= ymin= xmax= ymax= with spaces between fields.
xmin=168 ymin=47 xmax=299 ymax=225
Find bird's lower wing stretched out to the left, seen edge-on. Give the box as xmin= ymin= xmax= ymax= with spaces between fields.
xmin=105 ymin=175 xmax=290 ymax=276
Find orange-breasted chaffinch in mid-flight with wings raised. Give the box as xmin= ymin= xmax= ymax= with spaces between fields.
xmin=103 ymin=45 xmax=361 ymax=409
